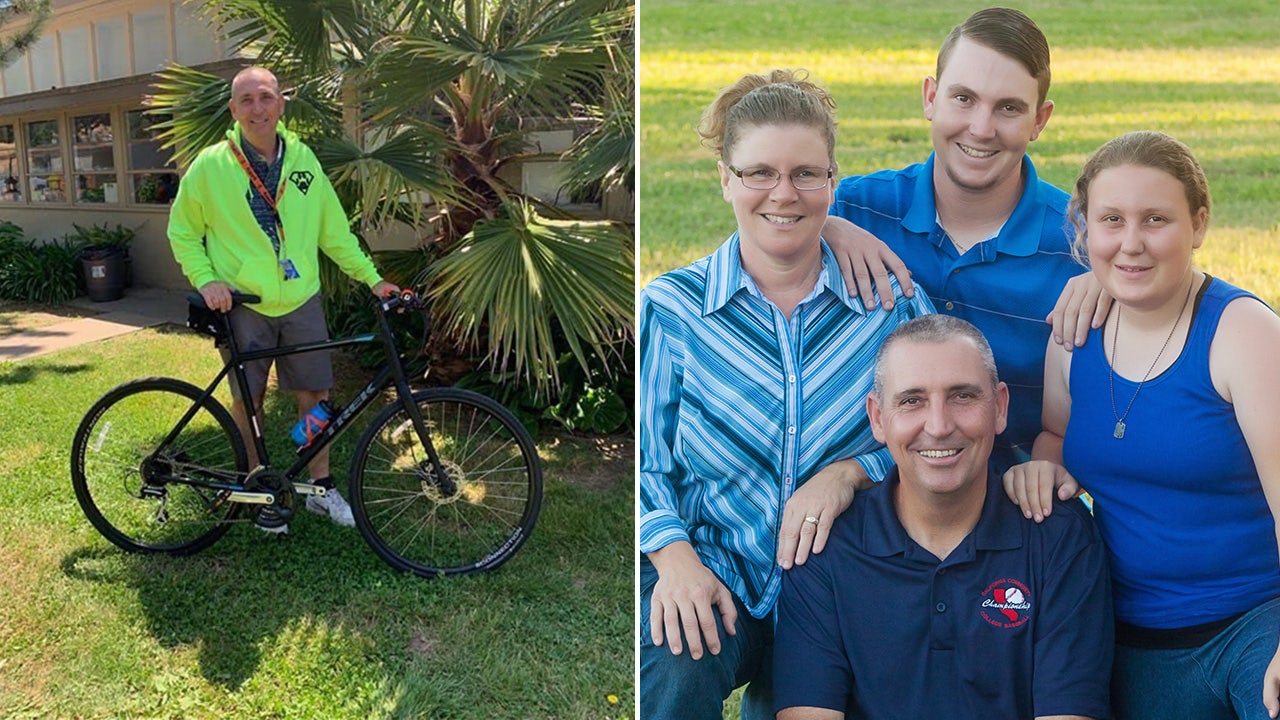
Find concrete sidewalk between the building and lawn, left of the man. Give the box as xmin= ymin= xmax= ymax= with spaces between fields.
xmin=0 ymin=287 xmax=188 ymax=363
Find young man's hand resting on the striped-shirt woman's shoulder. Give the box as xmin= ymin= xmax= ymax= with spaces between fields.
xmin=822 ymin=217 xmax=915 ymax=310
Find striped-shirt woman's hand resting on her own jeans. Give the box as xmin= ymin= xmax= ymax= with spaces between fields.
xmin=649 ymin=541 xmax=737 ymax=660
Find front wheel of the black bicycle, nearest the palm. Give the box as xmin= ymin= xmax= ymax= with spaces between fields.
xmin=349 ymin=388 xmax=543 ymax=578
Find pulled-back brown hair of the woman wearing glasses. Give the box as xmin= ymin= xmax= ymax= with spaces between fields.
xmin=698 ymin=69 xmax=836 ymax=167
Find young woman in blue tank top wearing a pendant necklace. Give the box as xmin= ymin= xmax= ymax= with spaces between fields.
xmin=1005 ymin=132 xmax=1280 ymax=720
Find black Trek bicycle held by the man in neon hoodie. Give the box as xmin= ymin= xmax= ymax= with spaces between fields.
xmin=72 ymin=292 xmax=543 ymax=578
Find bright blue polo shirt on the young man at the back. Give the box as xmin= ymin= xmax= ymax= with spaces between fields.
xmin=831 ymin=154 xmax=1084 ymax=473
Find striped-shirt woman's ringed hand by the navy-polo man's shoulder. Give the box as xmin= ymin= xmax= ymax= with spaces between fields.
xmin=778 ymin=460 xmax=870 ymax=570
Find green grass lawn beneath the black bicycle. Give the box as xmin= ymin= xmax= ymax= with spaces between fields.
xmin=0 ymin=329 xmax=635 ymax=719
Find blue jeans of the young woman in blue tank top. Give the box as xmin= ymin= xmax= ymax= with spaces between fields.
xmin=1111 ymin=598 xmax=1280 ymax=720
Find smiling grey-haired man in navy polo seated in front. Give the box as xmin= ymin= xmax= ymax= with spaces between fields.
xmin=773 ymin=314 xmax=1114 ymax=720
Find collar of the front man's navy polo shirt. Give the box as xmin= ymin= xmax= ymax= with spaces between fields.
xmin=861 ymin=468 xmax=1030 ymax=564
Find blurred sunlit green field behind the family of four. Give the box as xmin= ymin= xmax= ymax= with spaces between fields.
xmin=639 ymin=0 xmax=1280 ymax=306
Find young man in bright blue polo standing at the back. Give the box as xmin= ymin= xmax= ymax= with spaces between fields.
xmin=823 ymin=8 xmax=1105 ymax=471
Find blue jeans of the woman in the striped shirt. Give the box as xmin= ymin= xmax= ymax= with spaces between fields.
xmin=640 ymin=573 xmax=773 ymax=720
